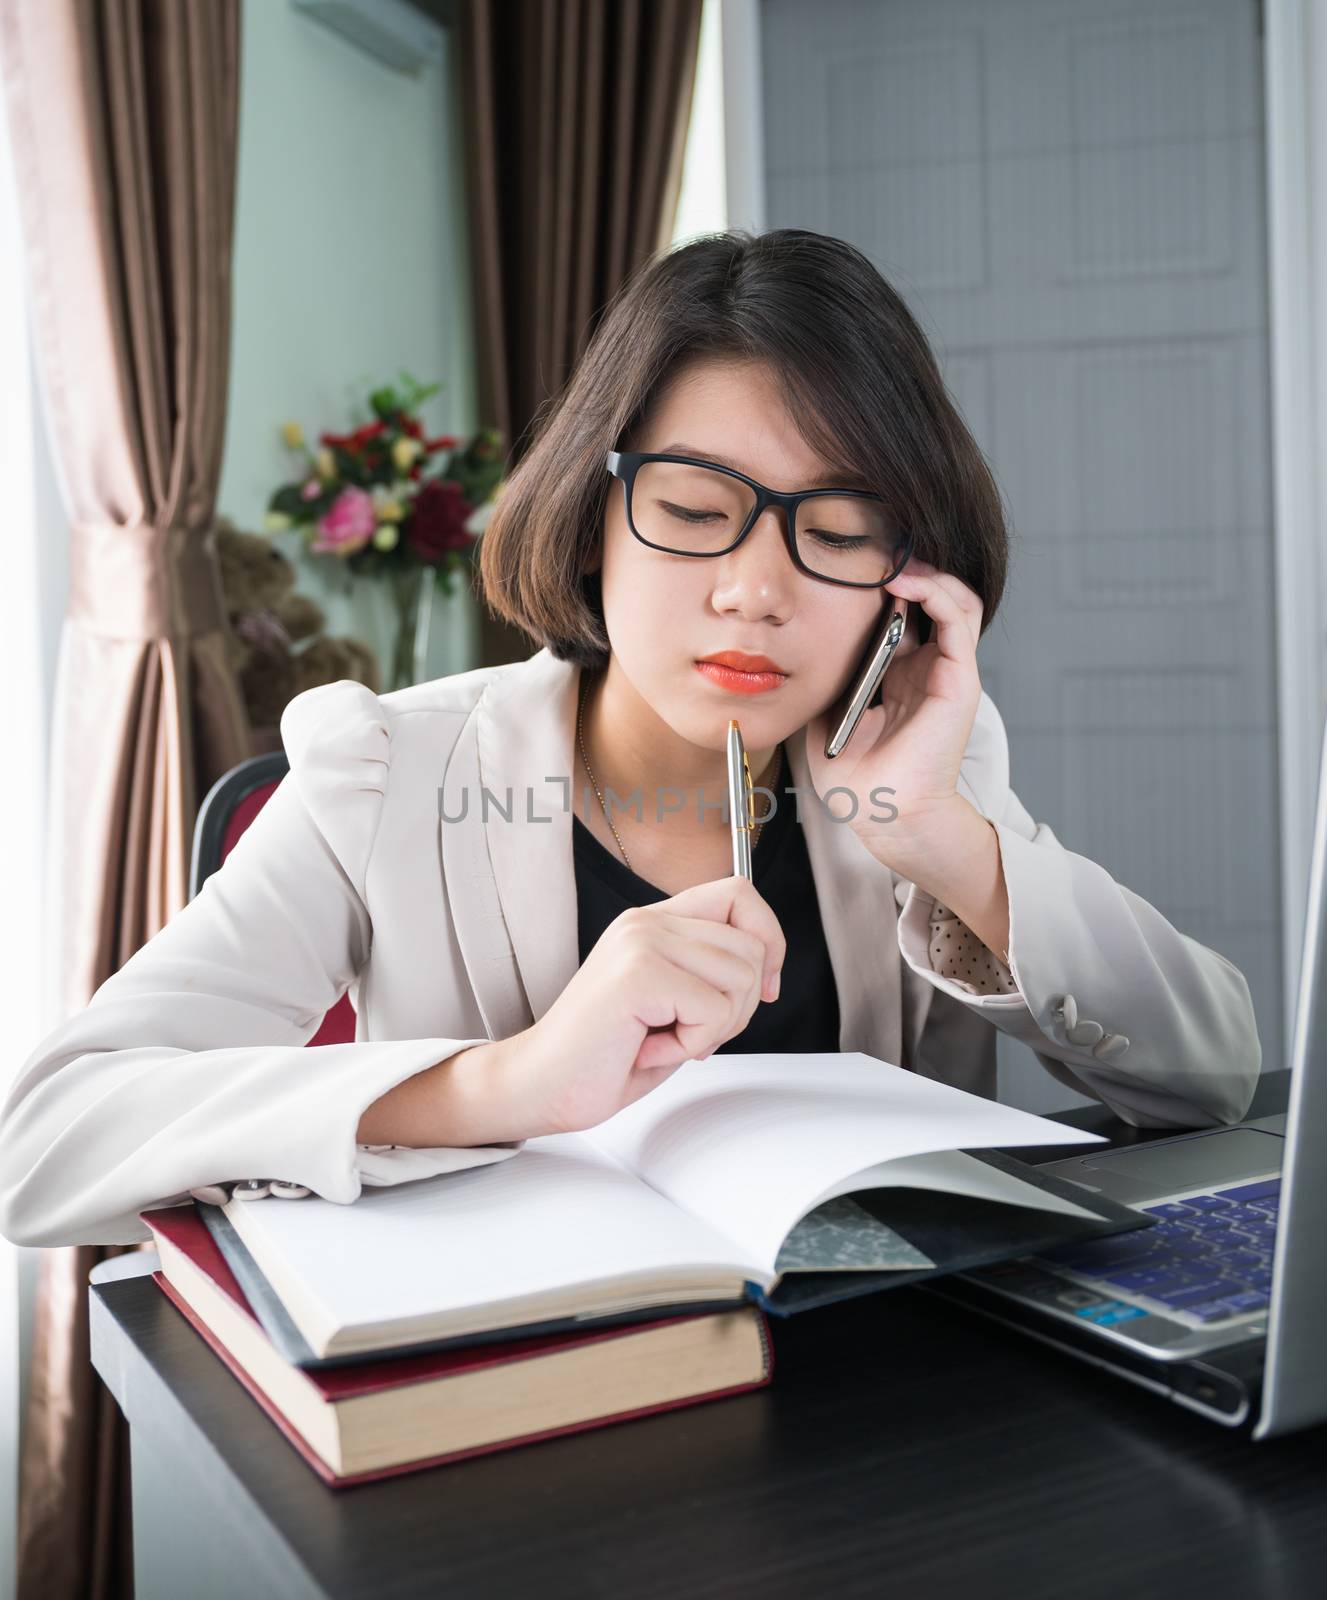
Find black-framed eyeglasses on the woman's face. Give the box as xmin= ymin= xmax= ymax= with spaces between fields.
xmin=607 ymin=450 xmax=916 ymax=589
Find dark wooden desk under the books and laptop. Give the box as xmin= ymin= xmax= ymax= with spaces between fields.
xmin=90 ymin=1072 xmax=1327 ymax=1600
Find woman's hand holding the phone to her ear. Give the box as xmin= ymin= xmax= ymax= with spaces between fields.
xmin=807 ymin=555 xmax=981 ymax=866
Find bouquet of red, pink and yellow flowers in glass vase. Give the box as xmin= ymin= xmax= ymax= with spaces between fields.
xmin=266 ymin=373 xmax=503 ymax=690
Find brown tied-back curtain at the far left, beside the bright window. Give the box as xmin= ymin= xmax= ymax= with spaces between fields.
xmin=0 ymin=0 xmax=248 ymax=1600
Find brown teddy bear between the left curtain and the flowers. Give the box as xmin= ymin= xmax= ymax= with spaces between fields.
xmin=216 ymin=517 xmax=379 ymax=732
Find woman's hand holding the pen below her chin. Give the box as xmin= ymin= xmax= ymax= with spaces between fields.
xmin=503 ymin=875 xmax=786 ymax=1133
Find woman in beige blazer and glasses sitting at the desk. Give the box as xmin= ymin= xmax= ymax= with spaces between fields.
xmin=0 ymin=230 xmax=1260 ymax=1245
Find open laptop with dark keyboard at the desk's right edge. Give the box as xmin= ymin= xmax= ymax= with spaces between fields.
xmin=925 ymin=725 xmax=1327 ymax=1438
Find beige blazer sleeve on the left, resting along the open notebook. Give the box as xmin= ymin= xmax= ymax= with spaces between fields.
xmin=0 ymin=680 xmax=520 ymax=1245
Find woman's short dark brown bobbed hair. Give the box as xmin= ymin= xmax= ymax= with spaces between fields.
xmin=479 ymin=227 xmax=1008 ymax=670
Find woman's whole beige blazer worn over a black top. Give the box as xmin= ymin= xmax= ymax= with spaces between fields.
xmin=0 ymin=650 xmax=1261 ymax=1245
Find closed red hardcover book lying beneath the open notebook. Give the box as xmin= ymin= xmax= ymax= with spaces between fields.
xmin=139 ymin=1205 xmax=773 ymax=1488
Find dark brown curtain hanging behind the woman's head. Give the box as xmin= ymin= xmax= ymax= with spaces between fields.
xmin=458 ymin=0 xmax=701 ymax=666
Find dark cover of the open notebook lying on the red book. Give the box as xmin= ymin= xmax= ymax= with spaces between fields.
xmin=188 ymin=1150 xmax=1154 ymax=1371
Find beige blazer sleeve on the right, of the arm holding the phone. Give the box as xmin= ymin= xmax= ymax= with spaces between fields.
xmin=898 ymin=691 xmax=1261 ymax=1128
